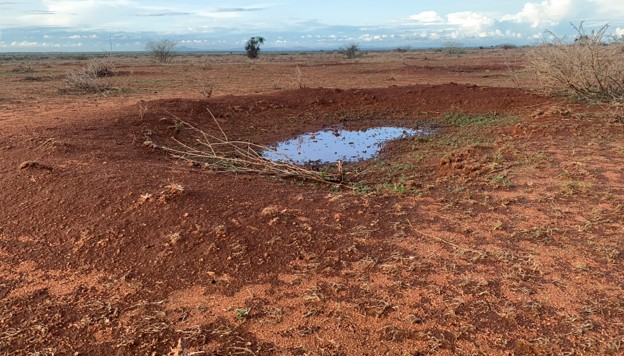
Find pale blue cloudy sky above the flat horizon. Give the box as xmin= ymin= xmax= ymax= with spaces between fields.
xmin=0 ymin=0 xmax=624 ymax=52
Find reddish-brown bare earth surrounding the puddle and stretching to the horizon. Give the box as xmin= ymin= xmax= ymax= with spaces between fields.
xmin=0 ymin=49 xmax=624 ymax=355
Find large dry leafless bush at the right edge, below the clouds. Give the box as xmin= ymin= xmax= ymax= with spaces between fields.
xmin=529 ymin=22 xmax=624 ymax=101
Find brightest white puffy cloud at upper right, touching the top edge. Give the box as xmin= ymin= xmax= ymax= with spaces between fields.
xmin=502 ymin=0 xmax=572 ymax=28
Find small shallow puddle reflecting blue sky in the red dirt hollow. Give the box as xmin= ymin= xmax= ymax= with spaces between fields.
xmin=262 ymin=127 xmax=427 ymax=164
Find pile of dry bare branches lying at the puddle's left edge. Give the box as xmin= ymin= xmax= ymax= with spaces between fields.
xmin=149 ymin=110 xmax=344 ymax=185
